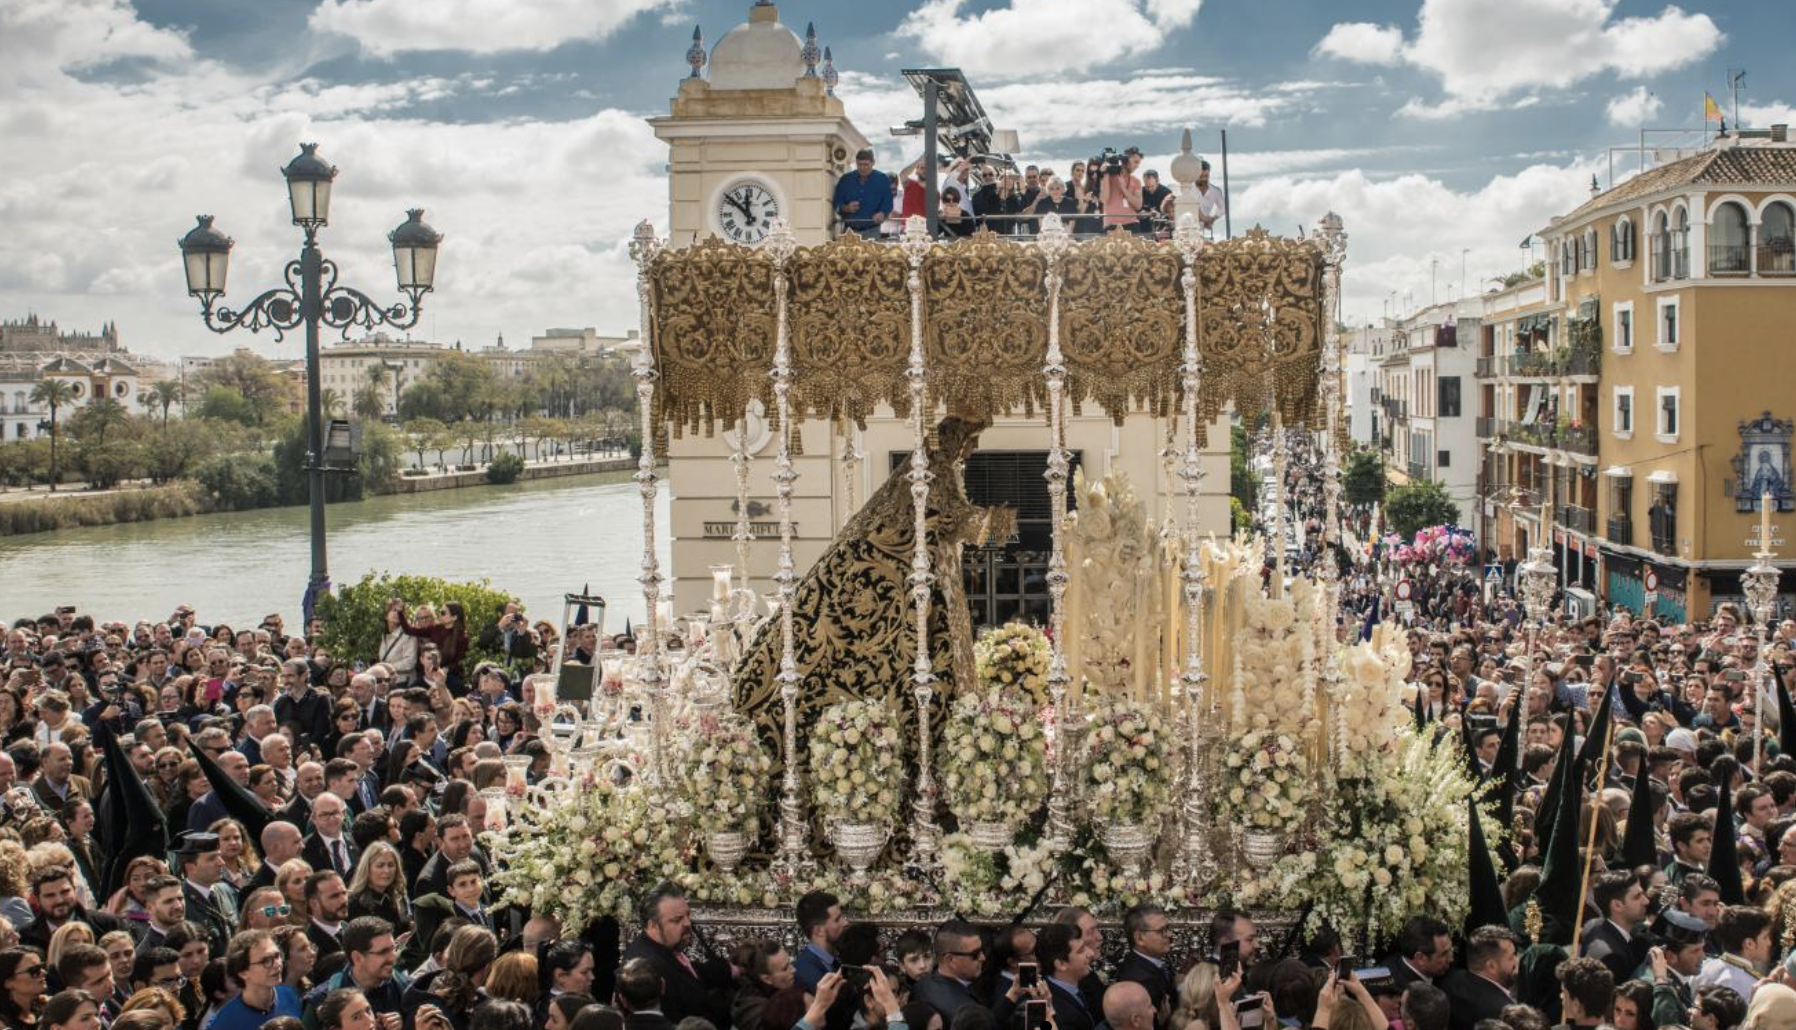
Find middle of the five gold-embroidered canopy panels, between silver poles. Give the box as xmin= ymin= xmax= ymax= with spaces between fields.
xmin=923 ymin=230 xmax=1047 ymax=417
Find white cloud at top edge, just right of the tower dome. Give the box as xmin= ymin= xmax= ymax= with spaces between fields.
xmin=898 ymin=0 xmax=1202 ymax=77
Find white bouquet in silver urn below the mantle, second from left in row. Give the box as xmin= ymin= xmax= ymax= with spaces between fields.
xmin=810 ymin=699 xmax=903 ymax=825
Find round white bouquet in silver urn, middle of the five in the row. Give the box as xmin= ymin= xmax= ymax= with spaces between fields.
xmin=939 ymin=687 xmax=1049 ymax=829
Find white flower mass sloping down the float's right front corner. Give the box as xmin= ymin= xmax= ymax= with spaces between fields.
xmin=1211 ymin=728 xmax=1494 ymax=938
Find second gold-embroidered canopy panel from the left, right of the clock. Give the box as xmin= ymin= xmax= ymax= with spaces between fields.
xmin=787 ymin=232 xmax=911 ymax=428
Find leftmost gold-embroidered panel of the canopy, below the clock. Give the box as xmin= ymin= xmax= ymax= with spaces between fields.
xmin=648 ymin=237 xmax=778 ymax=435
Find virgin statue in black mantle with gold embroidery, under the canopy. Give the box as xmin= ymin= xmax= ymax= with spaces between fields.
xmin=735 ymin=415 xmax=1015 ymax=782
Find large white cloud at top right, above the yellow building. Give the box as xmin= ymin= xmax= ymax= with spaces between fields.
xmin=1316 ymin=0 xmax=1724 ymax=119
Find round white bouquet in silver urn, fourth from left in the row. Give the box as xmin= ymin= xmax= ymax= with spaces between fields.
xmin=1079 ymin=697 xmax=1178 ymax=825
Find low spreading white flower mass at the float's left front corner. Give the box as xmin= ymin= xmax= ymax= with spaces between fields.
xmin=483 ymin=777 xmax=690 ymax=928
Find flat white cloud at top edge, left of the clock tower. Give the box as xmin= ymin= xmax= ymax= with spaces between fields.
xmin=311 ymin=0 xmax=684 ymax=56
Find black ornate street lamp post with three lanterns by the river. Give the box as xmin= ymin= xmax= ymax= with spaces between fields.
xmin=180 ymin=144 xmax=442 ymax=615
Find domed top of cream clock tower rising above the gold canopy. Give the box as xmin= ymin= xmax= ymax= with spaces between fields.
xmin=648 ymin=0 xmax=867 ymax=246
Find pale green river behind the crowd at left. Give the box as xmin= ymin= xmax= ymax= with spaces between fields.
xmin=0 ymin=473 xmax=670 ymax=627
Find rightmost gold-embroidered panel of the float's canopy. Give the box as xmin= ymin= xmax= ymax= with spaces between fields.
xmin=1198 ymin=226 xmax=1324 ymax=426
